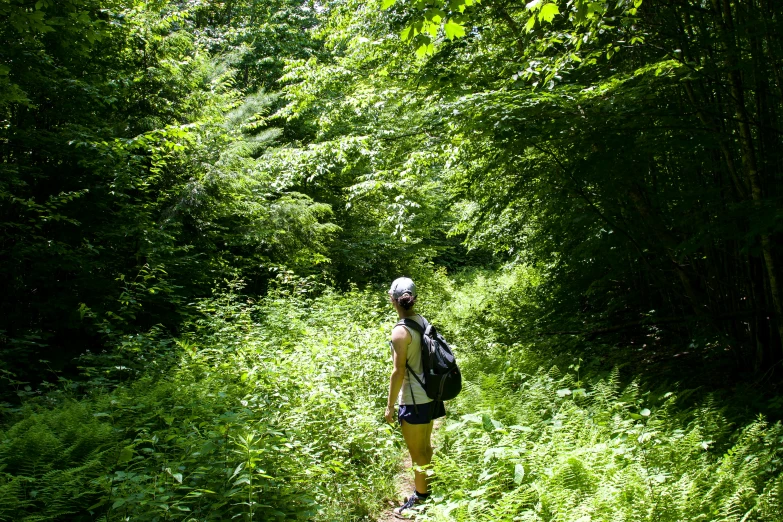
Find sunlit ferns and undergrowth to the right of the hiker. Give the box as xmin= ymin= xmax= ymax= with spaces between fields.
xmin=419 ymin=269 xmax=783 ymax=522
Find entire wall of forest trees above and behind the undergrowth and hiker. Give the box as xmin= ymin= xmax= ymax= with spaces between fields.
xmin=0 ymin=0 xmax=783 ymax=520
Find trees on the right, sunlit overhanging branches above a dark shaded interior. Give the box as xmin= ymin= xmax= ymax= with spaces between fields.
xmin=288 ymin=0 xmax=783 ymax=372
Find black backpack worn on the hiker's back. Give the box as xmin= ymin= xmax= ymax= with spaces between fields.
xmin=397 ymin=316 xmax=462 ymax=406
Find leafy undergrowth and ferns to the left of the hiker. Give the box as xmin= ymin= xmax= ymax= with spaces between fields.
xmin=0 ymin=282 xmax=401 ymax=521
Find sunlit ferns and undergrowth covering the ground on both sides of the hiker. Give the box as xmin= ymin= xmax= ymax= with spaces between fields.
xmin=0 ymin=268 xmax=783 ymax=522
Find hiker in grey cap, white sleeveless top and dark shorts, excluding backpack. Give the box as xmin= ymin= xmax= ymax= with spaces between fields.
xmin=384 ymin=277 xmax=446 ymax=515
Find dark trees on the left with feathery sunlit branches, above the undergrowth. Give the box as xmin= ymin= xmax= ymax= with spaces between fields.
xmin=0 ymin=1 xmax=335 ymax=378
